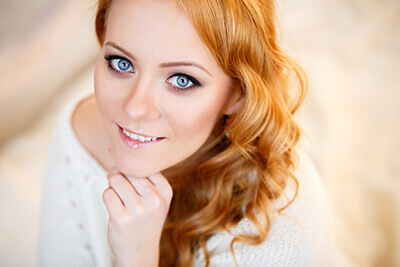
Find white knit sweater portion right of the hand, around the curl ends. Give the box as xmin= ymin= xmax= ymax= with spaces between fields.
xmin=194 ymin=152 xmax=335 ymax=266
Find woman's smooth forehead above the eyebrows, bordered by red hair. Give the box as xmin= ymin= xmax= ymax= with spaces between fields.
xmin=106 ymin=0 xmax=213 ymax=67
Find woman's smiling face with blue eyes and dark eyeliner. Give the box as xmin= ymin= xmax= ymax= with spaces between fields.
xmin=95 ymin=0 xmax=236 ymax=177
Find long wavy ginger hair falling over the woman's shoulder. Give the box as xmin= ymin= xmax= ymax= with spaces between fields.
xmin=96 ymin=0 xmax=307 ymax=266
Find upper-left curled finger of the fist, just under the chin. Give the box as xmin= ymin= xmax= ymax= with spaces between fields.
xmin=108 ymin=173 xmax=139 ymax=208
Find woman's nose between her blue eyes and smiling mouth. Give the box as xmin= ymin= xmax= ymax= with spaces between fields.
xmin=124 ymin=80 xmax=161 ymax=120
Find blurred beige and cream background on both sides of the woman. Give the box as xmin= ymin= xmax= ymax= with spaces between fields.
xmin=0 ymin=0 xmax=400 ymax=266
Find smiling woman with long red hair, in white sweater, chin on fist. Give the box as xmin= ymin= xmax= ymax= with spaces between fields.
xmin=39 ymin=0 xmax=338 ymax=266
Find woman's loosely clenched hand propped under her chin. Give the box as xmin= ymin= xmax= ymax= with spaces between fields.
xmin=103 ymin=167 xmax=172 ymax=267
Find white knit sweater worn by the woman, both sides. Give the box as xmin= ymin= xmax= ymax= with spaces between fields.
xmin=39 ymin=95 xmax=335 ymax=267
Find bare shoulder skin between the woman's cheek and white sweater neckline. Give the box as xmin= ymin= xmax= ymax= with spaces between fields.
xmin=71 ymin=95 xmax=113 ymax=172
